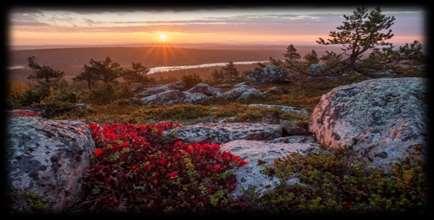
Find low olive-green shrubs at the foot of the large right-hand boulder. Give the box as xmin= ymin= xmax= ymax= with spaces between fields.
xmin=251 ymin=152 xmax=427 ymax=213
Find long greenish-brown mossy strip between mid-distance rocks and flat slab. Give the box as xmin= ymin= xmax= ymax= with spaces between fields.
xmin=53 ymin=102 xmax=308 ymax=123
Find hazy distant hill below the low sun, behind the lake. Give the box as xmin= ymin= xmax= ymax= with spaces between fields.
xmin=9 ymin=45 xmax=338 ymax=80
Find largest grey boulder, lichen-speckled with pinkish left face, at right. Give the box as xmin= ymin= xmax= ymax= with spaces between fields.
xmin=310 ymin=77 xmax=428 ymax=170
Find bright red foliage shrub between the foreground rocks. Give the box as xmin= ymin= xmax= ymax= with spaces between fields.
xmin=81 ymin=122 xmax=245 ymax=212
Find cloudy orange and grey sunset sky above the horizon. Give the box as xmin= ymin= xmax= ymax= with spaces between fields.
xmin=9 ymin=7 xmax=425 ymax=47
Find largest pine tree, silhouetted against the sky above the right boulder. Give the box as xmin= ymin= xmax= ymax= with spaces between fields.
xmin=317 ymin=7 xmax=395 ymax=69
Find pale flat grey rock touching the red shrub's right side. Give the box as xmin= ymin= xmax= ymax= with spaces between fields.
xmin=221 ymin=140 xmax=319 ymax=197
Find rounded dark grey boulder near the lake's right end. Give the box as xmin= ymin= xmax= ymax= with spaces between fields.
xmin=247 ymin=64 xmax=288 ymax=83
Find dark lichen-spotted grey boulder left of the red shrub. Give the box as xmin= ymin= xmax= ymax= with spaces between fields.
xmin=7 ymin=117 xmax=94 ymax=211
